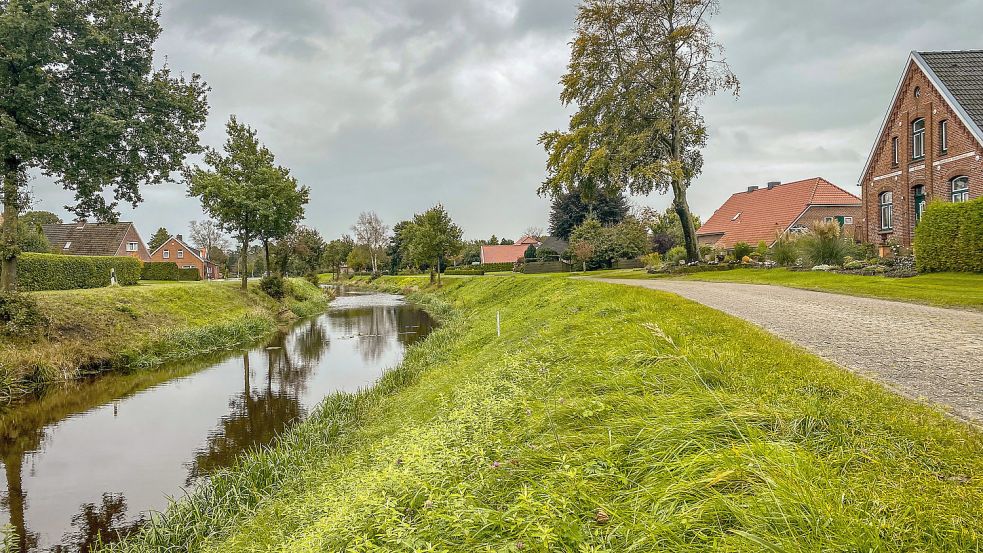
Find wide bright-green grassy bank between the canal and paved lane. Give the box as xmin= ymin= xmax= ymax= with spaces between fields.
xmin=107 ymin=277 xmax=983 ymax=552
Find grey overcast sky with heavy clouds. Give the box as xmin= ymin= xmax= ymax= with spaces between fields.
xmin=26 ymin=0 xmax=983 ymax=240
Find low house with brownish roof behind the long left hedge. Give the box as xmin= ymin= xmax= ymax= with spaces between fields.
xmin=41 ymin=222 xmax=150 ymax=262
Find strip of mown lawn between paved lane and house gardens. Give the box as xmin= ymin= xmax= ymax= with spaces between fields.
xmin=588 ymin=269 xmax=983 ymax=309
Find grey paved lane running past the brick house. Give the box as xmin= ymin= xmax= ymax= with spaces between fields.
xmin=592 ymin=279 xmax=983 ymax=422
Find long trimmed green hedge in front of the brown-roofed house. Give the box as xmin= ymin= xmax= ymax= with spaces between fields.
xmin=17 ymin=253 xmax=141 ymax=292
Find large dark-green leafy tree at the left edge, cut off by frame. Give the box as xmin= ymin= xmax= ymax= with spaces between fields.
xmin=0 ymin=0 xmax=208 ymax=291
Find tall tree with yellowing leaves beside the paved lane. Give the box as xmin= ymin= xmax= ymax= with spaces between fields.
xmin=540 ymin=0 xmax=739 ymax=261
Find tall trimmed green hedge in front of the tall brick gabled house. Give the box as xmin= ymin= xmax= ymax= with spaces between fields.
xmin=915 ymin=198 xmax=983 ymax=273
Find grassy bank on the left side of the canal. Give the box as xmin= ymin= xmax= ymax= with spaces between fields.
xmin=0 ymin=279 xmax=328 ymax=400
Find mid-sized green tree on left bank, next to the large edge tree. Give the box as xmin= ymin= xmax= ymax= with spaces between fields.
xmin=185 ymin=116 xmax=296 ymax=290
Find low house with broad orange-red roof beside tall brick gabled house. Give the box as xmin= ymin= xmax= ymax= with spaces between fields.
xmin=696 ymin=177 xmax=863 ymax=249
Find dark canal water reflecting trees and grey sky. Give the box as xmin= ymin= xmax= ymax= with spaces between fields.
xmin=0 ymin=294 xmax=433 ymax=552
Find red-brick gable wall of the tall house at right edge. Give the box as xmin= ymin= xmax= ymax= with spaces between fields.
xmin=858 ymin=63 xmax=983 ymax=247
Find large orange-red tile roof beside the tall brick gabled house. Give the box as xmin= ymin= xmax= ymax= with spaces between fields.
xmin=696 ymin=177 xmax=861 ymax=248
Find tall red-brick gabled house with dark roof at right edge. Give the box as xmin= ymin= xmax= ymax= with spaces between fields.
xmin=860 ymin=50 xmax=983 ymax=254
